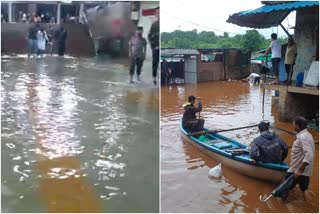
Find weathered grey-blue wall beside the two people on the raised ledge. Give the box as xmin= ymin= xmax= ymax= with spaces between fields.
xmin=293 ymin=7 xmax=319 ymax=79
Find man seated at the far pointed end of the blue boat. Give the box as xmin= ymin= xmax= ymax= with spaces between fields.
xmin=182 ymin=96 xmax=204 ymax=132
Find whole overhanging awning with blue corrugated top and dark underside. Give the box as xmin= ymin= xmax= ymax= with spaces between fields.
xmin=227 ymin=1 xmax=319 ymax=28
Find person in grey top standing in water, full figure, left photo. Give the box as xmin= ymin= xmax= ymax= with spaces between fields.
xmin=129 ymin=27 xmax=147 ymax=83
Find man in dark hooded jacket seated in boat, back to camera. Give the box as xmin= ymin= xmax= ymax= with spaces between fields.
xmin=249 ymin=121 xmax=288 ymax=163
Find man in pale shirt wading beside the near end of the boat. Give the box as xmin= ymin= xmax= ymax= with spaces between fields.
xmin=282 ymin=116 xmax=315 ymax=200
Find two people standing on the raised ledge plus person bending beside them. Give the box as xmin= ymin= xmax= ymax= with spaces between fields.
xmin=244 ymin=33 xmax=297 ymax=84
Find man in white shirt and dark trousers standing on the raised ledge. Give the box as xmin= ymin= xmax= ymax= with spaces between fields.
xmin=264 ymin=33 xmax=281 ymax=84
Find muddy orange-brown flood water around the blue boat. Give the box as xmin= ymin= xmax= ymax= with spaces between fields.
xmin=160 ymin=81 xmax=319 ymax=213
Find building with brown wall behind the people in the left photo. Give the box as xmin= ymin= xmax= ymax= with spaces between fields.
xmin=1 ymin=1 xmax=159 ymax=57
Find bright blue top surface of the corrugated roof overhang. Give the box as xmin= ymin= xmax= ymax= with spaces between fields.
xmin=239 ymin=1 xmax=319 ymax=16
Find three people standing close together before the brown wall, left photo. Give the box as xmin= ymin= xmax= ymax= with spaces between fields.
xmin=28 ymin=22 xmax=67 ymax=58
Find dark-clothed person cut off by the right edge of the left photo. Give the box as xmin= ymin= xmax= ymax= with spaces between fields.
xmin=148 ymin=8 xmax=160 ymax=85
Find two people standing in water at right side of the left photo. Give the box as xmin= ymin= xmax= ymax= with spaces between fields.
xmin=129 ymin=9 xmax=160 ymax=85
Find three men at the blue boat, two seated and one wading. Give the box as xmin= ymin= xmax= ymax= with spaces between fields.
xmin=182 ymin=96 xmax=315 ymax=200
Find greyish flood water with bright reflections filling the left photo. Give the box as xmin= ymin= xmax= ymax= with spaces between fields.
xmin=1 ymin=57 xmax=159 ymax=213
